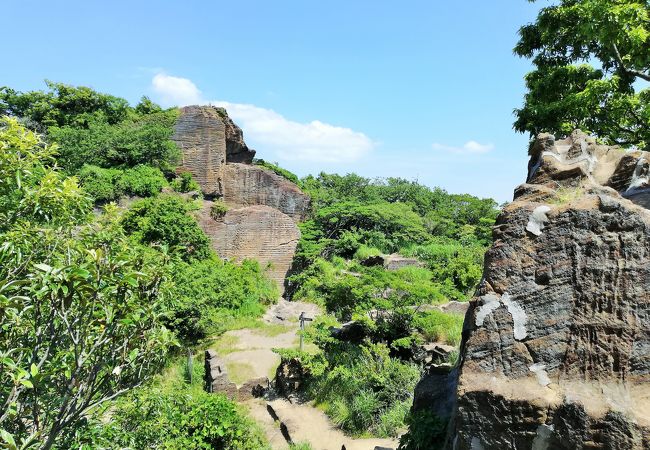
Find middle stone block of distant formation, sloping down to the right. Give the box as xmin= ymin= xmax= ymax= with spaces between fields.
xmin=223 ymin=164 xmax=309 ymax=221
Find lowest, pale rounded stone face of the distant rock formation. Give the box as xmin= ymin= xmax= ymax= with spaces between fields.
xmin=199 ymin=201 xmax=300 ymax=291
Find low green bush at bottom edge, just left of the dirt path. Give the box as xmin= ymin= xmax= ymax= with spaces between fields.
xmin=75 ymin=358 xmax=268 ymax=450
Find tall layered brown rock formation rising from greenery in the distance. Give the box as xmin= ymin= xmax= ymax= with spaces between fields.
xmin=172 ymin=106 xmax=309 ymax=288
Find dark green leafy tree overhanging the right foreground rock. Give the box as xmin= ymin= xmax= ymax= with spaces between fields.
xmin=514 ymin=0 xmax=650 ymax=149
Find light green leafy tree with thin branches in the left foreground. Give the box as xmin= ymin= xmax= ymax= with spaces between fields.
xmin=0 ymin=119 xmax=174 ymax=449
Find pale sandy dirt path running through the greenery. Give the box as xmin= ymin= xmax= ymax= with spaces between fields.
xmin=210 ymin=300 xmax=398 ymax=450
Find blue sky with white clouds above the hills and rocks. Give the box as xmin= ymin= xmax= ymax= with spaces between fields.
xmin=0 ymin=0 xmax=546 ymax=202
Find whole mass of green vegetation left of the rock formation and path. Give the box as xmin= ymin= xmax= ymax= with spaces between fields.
xmin=0 ymin=83 xmax=278 ymax=449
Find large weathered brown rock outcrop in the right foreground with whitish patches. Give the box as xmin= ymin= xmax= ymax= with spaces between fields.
xmin=429 ymin=132 xmax=650 ymax=450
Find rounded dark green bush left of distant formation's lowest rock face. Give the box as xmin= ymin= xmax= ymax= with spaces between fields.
xmin=122 ymin=195 xmax=211 ymax=261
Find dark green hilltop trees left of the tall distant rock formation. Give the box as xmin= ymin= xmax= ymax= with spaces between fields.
xmin=0 ymin=81 xmax=180 ymax=173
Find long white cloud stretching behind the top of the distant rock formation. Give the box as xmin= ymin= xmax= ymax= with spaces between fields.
xmin=152 ymin=73 xmax=375 ymax=163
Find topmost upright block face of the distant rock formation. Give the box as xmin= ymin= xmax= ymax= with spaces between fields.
xmin=172 ymin=106 xmax=226 ymax=197
